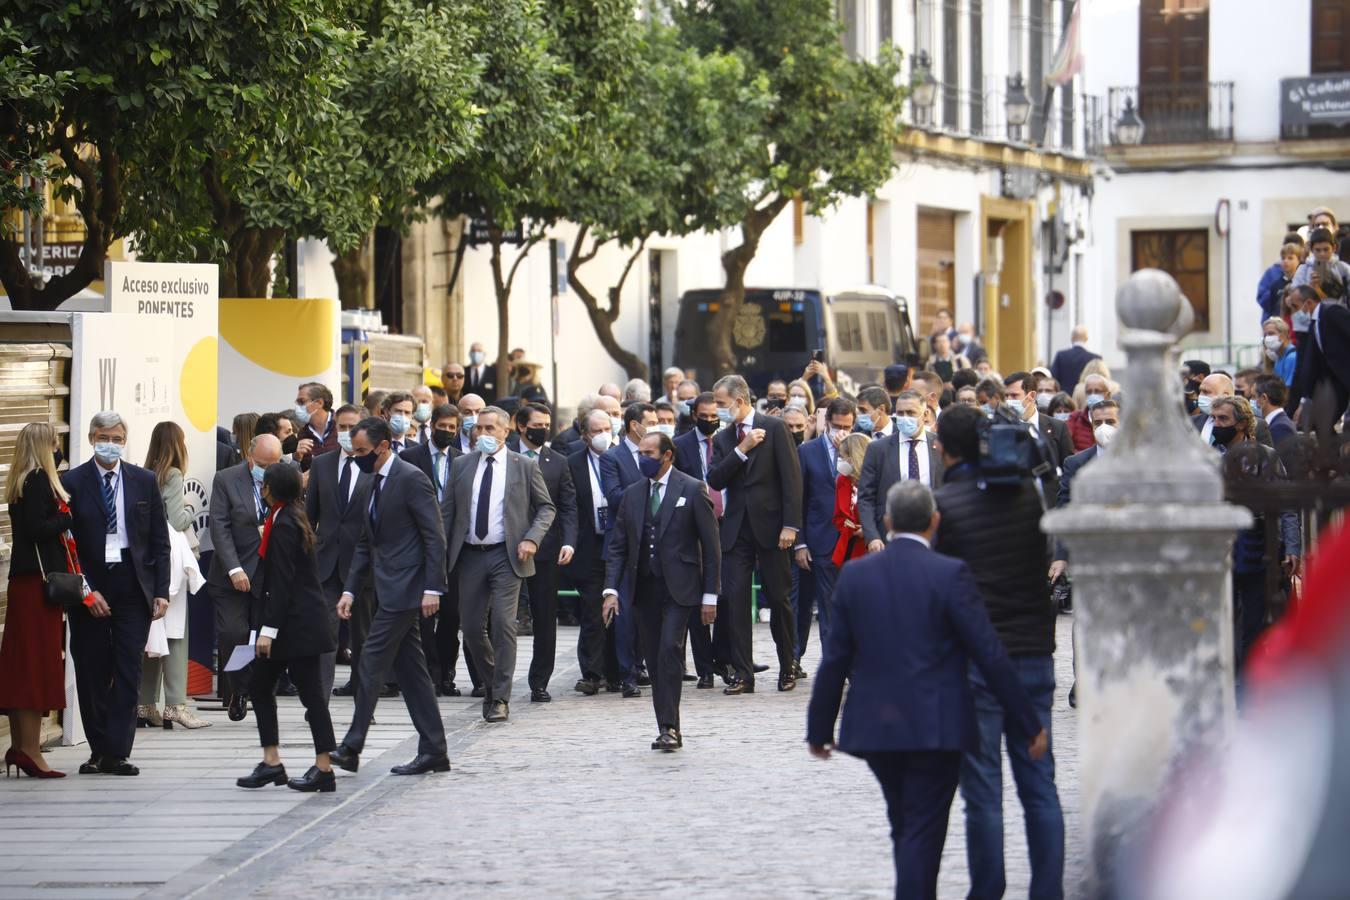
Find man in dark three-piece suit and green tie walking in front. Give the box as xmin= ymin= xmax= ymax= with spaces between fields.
xmin=605 ymin=430 xmax=721 ymax=752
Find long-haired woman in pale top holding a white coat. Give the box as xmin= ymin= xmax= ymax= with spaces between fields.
xmin=136 ymin=422 xmax=211 ymax=729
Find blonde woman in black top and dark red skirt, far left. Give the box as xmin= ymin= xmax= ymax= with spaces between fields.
xmin=0 ymin=422 xmax=70 ymax=779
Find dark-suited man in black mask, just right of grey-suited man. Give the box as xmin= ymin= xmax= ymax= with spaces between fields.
xmin=518 ymin=403 xmax=576 ymax=703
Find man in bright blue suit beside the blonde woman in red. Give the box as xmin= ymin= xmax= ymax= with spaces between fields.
xmin=794 ymin=397 xmax=853 ymax=658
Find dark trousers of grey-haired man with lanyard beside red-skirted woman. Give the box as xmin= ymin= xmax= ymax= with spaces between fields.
xmin=70 ymin=563 xmax=149 ymax=760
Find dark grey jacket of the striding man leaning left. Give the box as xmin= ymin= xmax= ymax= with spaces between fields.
xmin=347 ymin=457 xmax=446 ymax=611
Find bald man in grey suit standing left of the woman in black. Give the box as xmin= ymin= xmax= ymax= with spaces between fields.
xmin=207 ymin=434 xmax=281 ymax=722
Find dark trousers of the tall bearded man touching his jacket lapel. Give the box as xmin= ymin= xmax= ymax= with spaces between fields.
xmin=717 ymin=522 xmax=797 ymax=684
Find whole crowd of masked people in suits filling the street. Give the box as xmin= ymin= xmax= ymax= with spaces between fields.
xmin=0 ymin=253 xmax=1350 ymax=896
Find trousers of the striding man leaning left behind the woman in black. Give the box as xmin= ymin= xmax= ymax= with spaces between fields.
xmin=342 ymin=606 xmax=446 ymax=756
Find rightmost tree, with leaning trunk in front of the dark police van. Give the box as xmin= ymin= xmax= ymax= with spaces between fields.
xmin=668 ymin=0 xmax=906 ymax=372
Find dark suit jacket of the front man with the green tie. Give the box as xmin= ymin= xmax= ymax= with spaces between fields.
xmin=605 ymin=466 xmax=722 ymax=606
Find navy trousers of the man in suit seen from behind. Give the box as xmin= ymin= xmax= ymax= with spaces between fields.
xmin=864 ymin=750 xmax=973 ymax=900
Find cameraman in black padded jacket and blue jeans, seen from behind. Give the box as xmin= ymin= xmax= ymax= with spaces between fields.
xmin=934 ymin=405 xmax=1064 ymax=897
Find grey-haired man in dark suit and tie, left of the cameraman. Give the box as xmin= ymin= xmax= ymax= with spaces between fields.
xmin=858 ymin=390 xmax=942 ymax=553
